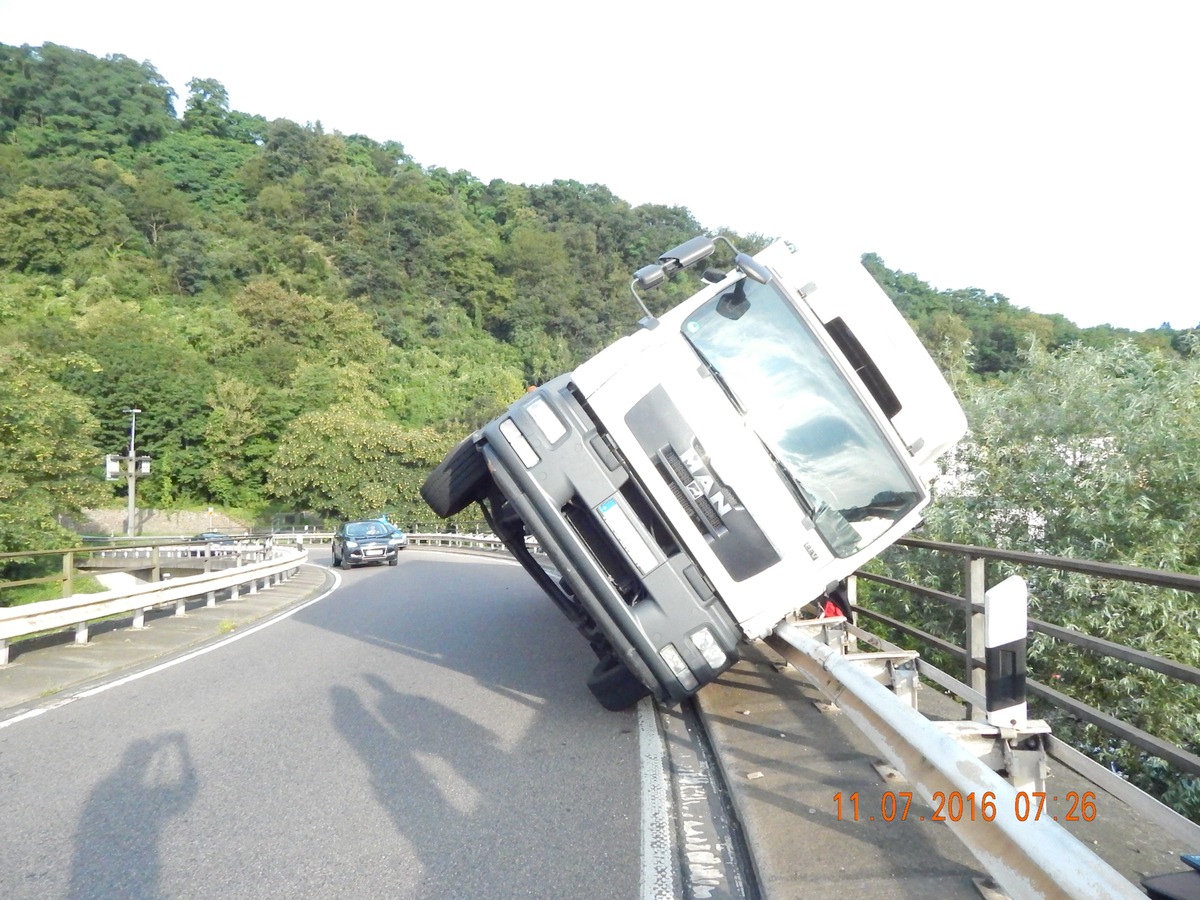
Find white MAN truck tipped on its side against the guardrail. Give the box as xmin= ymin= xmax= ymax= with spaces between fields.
xmin=421 ymin=236 xmax=966 ymax=709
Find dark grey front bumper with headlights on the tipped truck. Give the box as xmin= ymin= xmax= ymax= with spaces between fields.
xmin=480 ymin=377 xmax=742 ymax=702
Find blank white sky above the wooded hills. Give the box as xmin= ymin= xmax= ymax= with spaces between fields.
xmin=0 ymin=0 xmax=1200 ymax=330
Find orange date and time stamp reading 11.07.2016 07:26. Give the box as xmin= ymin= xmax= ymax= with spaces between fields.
xmin=833 ymin=791 xmax=1097 ymax=822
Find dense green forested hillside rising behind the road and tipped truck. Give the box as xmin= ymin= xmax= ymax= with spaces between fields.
xmin=0 ymin=44 xmax=1183 ymax=540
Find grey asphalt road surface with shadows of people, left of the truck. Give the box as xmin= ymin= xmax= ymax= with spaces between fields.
xmin=0 ymin=553 xmax=641 ymax=899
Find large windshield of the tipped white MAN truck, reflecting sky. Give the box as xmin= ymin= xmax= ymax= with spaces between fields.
xmin=683 ymin=278 xmax=920 ymax=557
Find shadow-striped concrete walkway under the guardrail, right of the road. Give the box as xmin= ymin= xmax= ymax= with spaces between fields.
xmin=698 ymin=646 xmax=1196 ymax=900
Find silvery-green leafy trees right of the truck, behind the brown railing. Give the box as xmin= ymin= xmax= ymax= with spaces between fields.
xmin=869 ymin=342 xmax=1200 ymax=816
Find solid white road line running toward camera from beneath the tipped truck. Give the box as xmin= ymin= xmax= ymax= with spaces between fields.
xmin=637 ymin=697 xmax=676 ymax=900
